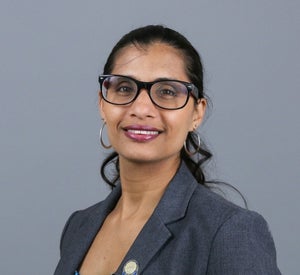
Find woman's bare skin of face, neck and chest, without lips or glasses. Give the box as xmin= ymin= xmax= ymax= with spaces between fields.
xmin=80 ymin=43 xmax=206 ymax=275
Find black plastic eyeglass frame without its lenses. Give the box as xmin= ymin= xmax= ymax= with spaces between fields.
xmin=98 ymin=74 xmax=200 ymax=110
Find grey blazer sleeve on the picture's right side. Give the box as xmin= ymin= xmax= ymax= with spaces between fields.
xmin=207 ymin=211 xmax=281 ymax=275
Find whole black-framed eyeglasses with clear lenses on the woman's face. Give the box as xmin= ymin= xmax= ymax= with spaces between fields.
xmin=99 ymin=75 xmax=198 ymax=110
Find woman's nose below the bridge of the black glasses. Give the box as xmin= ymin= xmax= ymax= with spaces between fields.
xmin=130 ymin=88 xmax=156 ymax=118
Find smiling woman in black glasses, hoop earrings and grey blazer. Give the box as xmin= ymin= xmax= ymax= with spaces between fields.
xmin=55 ymin=26 xmax=280 ymax=275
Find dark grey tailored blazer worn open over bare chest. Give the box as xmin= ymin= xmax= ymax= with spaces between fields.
xmin=54 ymin=164 xmax=281 ymax=275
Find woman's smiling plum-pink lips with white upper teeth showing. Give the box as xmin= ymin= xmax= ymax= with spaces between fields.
xmin=124 ymin=125 xmax=161 ymax=142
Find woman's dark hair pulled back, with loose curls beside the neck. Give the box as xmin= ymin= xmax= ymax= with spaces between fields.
xmin=101 ymin=25 xmax=212 ymax=190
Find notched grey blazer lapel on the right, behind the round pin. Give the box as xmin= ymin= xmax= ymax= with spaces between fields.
xmin=115 ymin=163 xmax=198 ymax=275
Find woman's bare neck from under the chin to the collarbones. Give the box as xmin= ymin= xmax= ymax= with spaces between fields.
xmin=116 ymin=158 xmax=180 ymax=221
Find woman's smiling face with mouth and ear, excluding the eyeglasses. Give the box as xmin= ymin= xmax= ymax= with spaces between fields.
xmin=100 ymin=43 xmax=206 ymax=165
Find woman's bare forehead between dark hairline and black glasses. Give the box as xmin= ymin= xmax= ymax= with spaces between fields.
xmin=112 ymin=42 xmax=189 ymax=81
